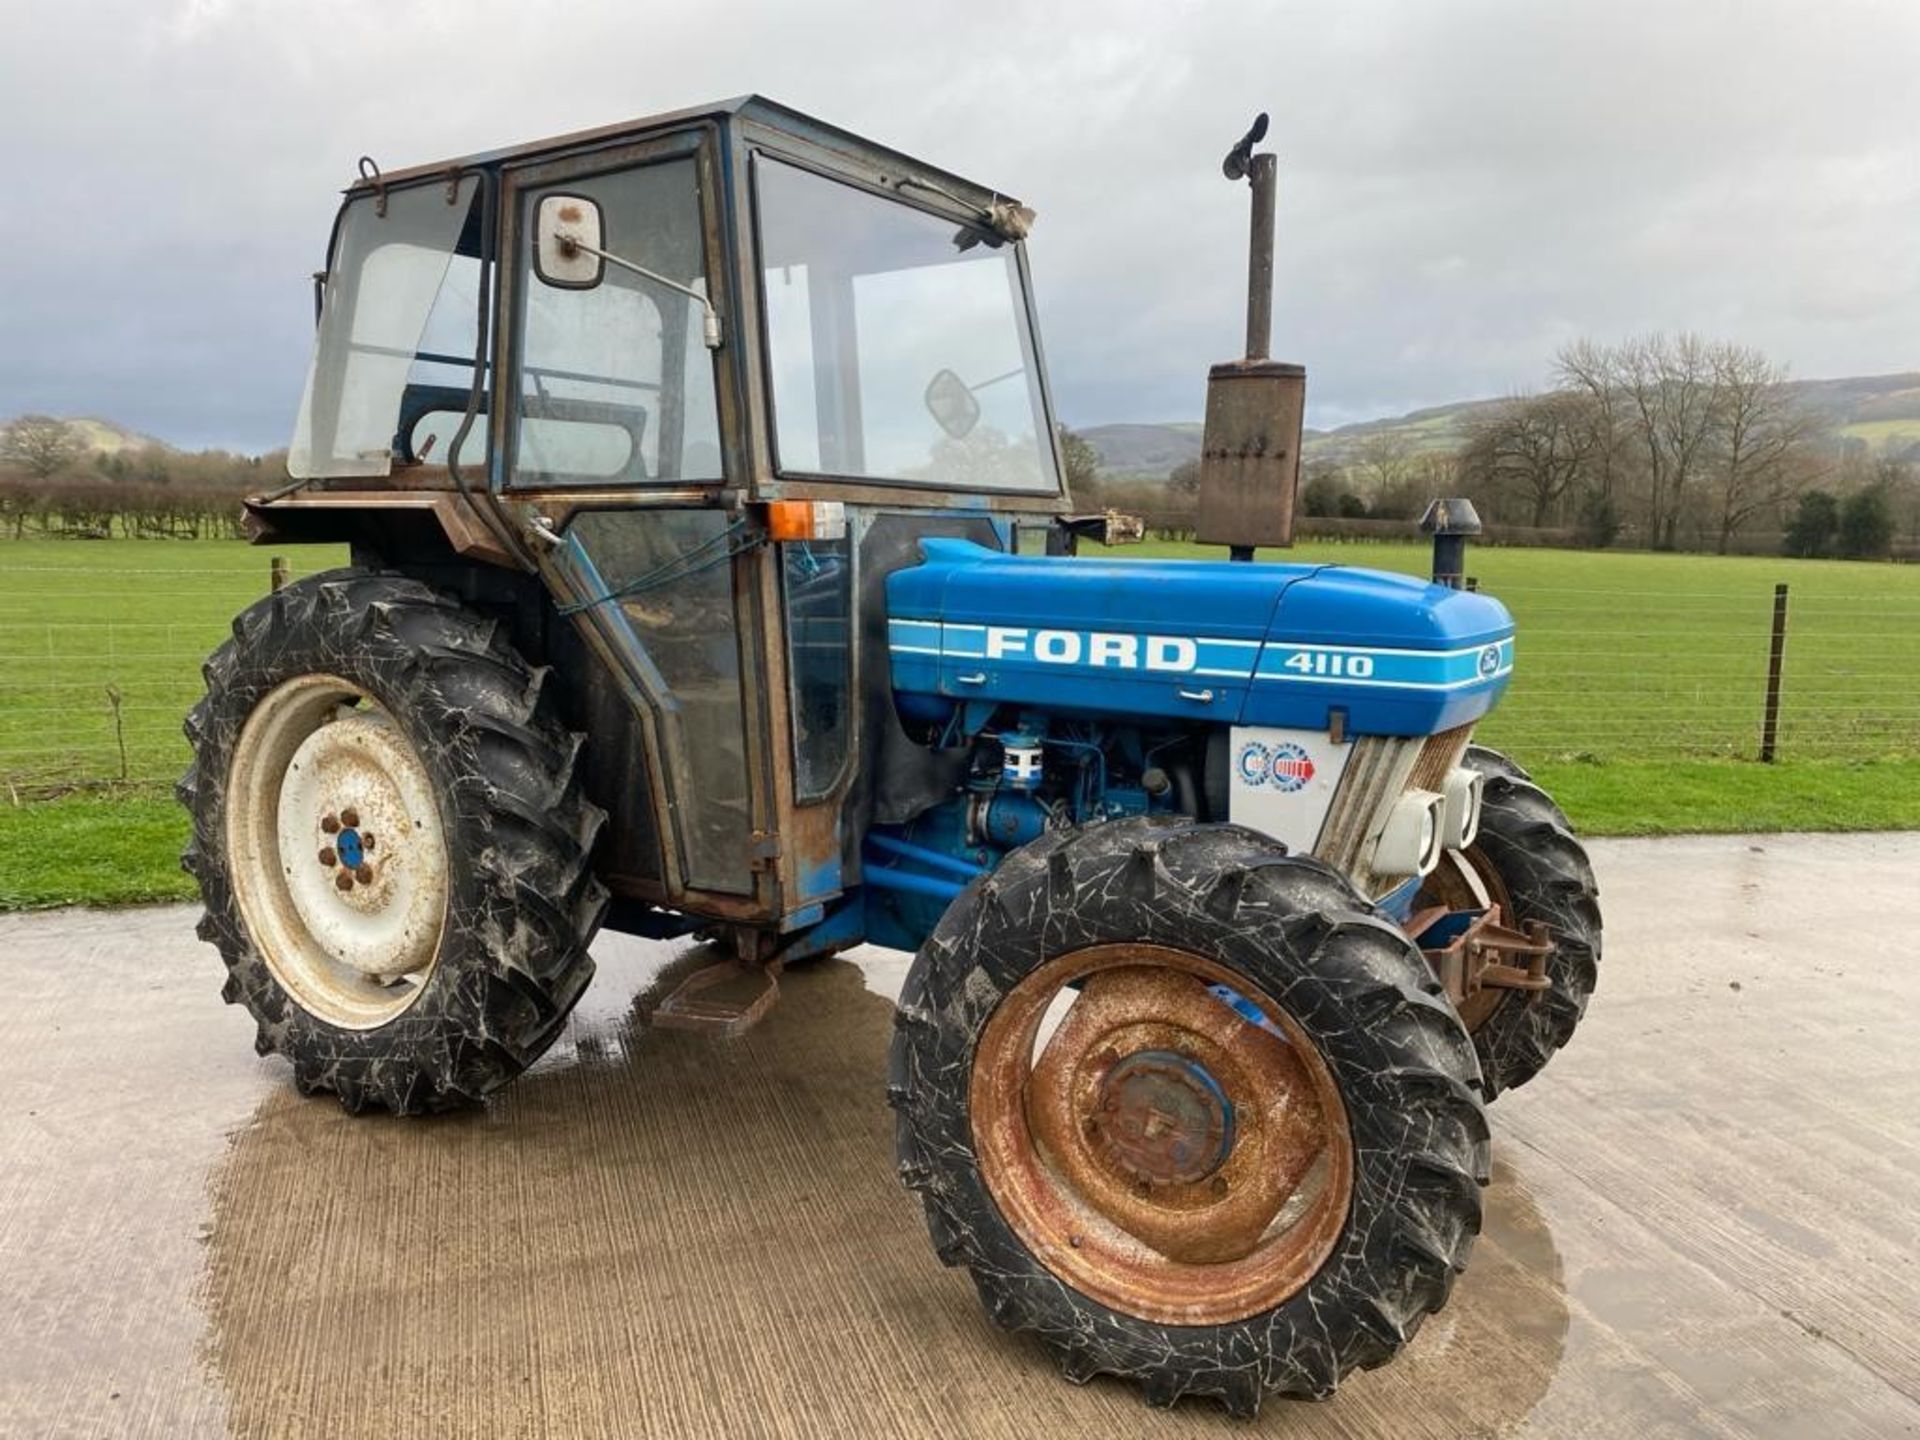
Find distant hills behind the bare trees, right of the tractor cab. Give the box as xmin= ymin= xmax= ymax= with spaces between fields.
xmin=1079 ymin=371 xmax=1920 ymax=476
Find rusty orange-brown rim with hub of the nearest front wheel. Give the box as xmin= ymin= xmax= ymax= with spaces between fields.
xmin=970 ymin=945 xmax=1354 ymax=1325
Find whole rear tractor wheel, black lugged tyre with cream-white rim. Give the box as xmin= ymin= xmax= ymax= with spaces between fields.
xmin=179 ymin=568 xmax=607 ymax=1114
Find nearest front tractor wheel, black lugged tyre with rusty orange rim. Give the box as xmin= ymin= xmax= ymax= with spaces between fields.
xmin=889 ymin=820 xmax=1488 ymax=1415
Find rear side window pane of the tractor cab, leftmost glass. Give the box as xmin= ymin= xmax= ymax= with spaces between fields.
xmin=286 ymin=177 xmax=480 ymax=480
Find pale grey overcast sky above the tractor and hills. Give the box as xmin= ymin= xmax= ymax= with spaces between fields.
xmin=0 ymin=0 xmax=1920 ymax=449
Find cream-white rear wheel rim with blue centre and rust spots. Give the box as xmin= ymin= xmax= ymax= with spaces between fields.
xmin=227 ymin=674 xmax=447 ymax=1029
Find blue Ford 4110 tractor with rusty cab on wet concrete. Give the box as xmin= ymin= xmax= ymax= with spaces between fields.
xmin=179 ymin=96 xmax=1601 ymax=1415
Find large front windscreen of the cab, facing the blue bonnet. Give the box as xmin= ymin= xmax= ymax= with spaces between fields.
xmin=755 ymin=156 xmax=1060 ymax=493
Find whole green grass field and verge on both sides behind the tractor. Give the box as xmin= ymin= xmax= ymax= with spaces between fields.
xmin=0 ymin=541 xmax=1920 ymax=908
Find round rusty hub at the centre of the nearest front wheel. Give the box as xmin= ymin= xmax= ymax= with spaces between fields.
xmin=1087 ymin=1050 xmax=1233 ymax=1185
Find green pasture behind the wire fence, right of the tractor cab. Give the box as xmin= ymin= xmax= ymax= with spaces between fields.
xmin=1114 ymin=541 xmax=1920 ymax=764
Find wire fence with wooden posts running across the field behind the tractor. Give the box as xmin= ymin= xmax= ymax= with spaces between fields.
xmin=0 ymin=545 xmax=1920 ymax=803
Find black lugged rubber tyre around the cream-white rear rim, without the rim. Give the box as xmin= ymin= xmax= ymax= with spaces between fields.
xmin=175 ymin=566 xmax=607 ymax=1114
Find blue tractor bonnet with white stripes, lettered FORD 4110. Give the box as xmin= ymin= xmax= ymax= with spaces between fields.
xmin=887 ymin=540 xmax=1513 ymax=735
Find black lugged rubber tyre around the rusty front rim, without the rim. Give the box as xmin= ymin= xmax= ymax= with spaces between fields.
xmin=889 ymin=818 xmax=1490 ymax=1415
